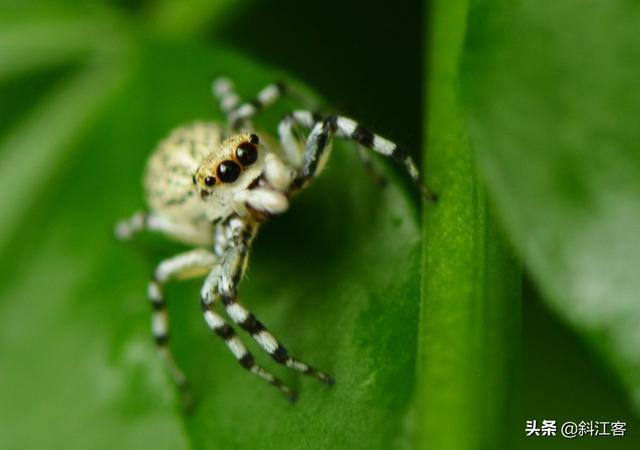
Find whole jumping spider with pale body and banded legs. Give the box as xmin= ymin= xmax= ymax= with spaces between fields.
xmin=116 ymin=79 xmax=432 ymax=408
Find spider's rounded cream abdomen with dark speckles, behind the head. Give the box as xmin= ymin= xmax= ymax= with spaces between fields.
xmin=144 ymin=122 xmax=224 ymax=225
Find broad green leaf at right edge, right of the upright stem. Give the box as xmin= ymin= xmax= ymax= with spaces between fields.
xmin=460 ymin=0 xmax=640 ymax=408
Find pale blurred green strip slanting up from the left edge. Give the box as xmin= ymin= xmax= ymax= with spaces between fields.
xmin=0 ymin=58 xmax=126 ymax=250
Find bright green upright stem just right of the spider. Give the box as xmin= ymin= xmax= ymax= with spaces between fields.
xmin=415 ymin=0 xmax=521 ymax=450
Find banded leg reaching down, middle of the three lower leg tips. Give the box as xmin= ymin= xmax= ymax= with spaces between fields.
xmin=201 ymin=270 xmax=297 ymax=402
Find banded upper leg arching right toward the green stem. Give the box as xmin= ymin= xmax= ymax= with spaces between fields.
xmin=291 ymin=111 xmax=435 ymax=201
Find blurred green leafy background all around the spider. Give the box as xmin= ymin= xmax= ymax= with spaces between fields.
xmin=0 ymin=0 xmax=640 ymax=450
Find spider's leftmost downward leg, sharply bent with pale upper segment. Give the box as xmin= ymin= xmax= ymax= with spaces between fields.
xmin=148 ymin=249 xmax=218 ymax=409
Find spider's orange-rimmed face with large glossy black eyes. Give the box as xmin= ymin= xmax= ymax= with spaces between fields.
xmin=193 ymin=134 xmax=266 ymax=220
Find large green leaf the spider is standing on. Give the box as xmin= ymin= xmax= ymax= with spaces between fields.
xmin=0 ymin=40 xmax=420 ymax=449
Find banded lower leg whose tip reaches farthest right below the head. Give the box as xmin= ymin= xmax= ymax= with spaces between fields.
xmin=218 ymin=246 xmax=335 ymax=385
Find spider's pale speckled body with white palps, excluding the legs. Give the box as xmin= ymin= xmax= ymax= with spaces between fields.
xmin=144 ymin=122 xmax=293 ymax=245
